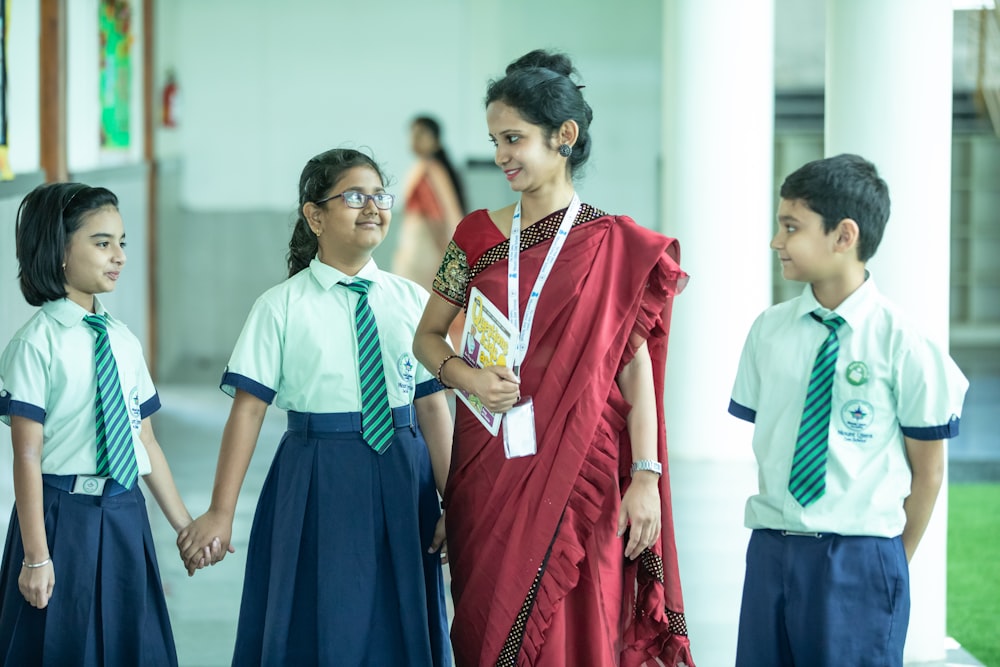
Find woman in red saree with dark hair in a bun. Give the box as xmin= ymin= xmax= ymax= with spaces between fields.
xmin=414 ymin=51 xmax=694 ymax=667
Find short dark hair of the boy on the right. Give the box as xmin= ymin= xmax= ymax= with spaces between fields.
xmin=780 ymin=153 xmax=889 ymax=262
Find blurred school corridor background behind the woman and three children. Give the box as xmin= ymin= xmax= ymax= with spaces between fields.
xmin=0 ymin=0 xmax=1000 ymax=667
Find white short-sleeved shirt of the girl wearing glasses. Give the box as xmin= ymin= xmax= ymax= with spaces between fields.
xmin=221 ymin=259 xmax=443 ymax=413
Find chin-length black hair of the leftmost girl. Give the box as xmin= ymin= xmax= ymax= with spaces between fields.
xmin=14 ymin=183 xmax=118 ymax=306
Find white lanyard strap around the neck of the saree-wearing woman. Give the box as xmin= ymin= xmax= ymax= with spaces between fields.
xmin=507 ymin=192 xmax=580 ymax=375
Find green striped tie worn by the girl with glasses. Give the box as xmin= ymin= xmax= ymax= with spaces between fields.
xmin=340 ymin=278 xmax=393 ymax=454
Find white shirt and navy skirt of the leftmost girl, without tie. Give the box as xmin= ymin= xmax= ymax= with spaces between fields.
xmin=0 ymin=297 xmax=177 ymax=666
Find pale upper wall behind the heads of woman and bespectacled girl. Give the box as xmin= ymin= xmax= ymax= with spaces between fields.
xmin=157 ymin=0 xmax=660 ymax=226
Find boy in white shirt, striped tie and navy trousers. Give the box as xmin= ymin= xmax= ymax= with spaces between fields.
xmin=729 ymin=155 xmax=968 ymax=667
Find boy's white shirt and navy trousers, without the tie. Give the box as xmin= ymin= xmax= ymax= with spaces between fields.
xmin=729 ymin=276 xmax=968 ymax=667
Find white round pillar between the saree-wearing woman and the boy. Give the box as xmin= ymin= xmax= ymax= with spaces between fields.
xmin=661 ymin=0 xmax=775 ymax=459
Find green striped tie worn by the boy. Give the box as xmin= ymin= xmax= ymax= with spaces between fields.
xmin=788 ymin=313 xmax=844 ymax=507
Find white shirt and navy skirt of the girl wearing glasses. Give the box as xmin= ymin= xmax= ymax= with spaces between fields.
xmin=221 ymin=260 xmax=451 ymax=666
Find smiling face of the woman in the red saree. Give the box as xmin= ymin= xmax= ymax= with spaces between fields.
xmin=486 ymin=101 xmax=569 ymax=192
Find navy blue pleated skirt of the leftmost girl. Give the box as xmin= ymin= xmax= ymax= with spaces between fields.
xmin=0 ymin=484 xmax=177 ymax=667
